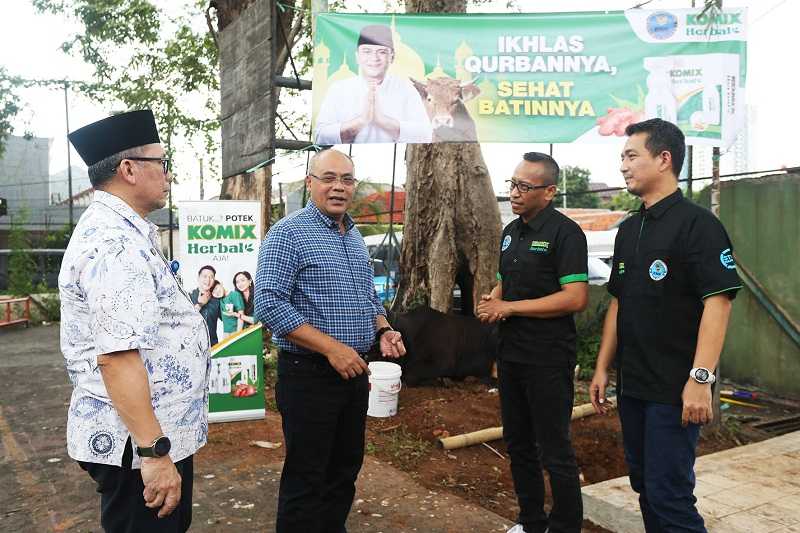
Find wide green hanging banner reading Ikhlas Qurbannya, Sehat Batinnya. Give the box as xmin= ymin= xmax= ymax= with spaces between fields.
xmin=312 ymin=8 xmax=747 ymax=147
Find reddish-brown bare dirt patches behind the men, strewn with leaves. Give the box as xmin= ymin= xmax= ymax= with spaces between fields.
xmin=199 ymin=358 xmax=781 ymax=532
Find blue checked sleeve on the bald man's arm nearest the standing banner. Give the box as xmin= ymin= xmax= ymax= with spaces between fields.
xmin=255 ymin=224 xmax=306 ymax=337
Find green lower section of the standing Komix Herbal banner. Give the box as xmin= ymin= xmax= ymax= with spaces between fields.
xmin=208 ymin=324 xmax=265 ymax=422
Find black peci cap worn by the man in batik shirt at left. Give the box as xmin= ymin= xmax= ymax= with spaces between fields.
xmin=67 ymin=109 xmax=161 ymax=166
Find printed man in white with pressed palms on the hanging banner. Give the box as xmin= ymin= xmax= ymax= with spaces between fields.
xmin=315 ymin=24 xmax=432 ymax=144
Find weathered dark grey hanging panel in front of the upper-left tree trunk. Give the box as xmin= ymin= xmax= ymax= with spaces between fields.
xmin=219 ymin=0 xmax=277 ymax=177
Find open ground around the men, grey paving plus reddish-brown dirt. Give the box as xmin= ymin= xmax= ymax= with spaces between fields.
xmin=0 ymin=325 xmax=800 ymax=533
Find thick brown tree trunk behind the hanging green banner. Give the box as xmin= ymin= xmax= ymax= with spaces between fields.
xmin=393 ymin=0 xmax=501 ymax=315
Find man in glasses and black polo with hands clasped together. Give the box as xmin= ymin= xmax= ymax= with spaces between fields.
xmin=478 ymin=152 xmax=589 ymax=533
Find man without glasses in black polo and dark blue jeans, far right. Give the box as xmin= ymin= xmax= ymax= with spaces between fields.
xmin=590 ymin=119 xmax=741 ymax=532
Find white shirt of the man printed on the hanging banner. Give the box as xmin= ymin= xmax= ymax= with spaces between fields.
xmin=316 ymin=74 xmax=433 ymax=144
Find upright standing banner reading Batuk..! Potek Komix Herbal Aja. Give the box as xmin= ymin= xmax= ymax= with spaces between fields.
xmin=177 ymin=200 xmax=265 ymax=422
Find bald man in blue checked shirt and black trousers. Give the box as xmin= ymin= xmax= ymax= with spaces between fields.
xmin=255 ymin=150 xmax=406 ymax=533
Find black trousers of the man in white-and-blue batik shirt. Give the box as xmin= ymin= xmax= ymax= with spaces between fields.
xmin=78 ymin=439 xmax=194 ymax=533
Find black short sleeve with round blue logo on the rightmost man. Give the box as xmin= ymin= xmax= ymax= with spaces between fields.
xmin=686 ymin=214 xmax=742 ymax=299
